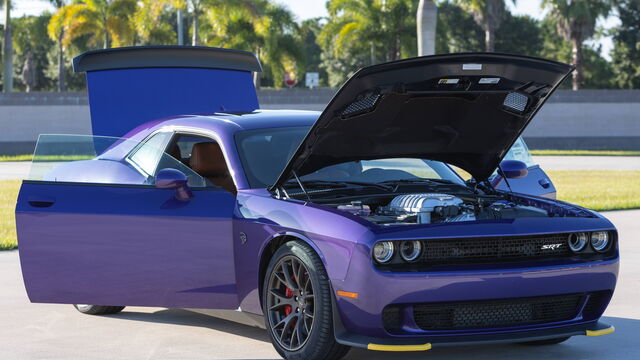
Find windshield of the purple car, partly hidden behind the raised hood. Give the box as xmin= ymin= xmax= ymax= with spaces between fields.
xmin=236 ymin=126 xmax=463 ymax=188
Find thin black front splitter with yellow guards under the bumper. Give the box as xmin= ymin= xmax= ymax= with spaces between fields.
xmin=336 ymin=321 xmax=615 ymax=351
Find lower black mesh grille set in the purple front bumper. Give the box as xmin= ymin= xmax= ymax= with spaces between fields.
xmin=413 ymin=294 xmax=585 ymax=331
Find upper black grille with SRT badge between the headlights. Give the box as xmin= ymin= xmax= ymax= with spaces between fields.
xmin=422 ymin=234 xmax=573 ymax=265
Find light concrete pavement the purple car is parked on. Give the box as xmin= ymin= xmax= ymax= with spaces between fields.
xmin=0 ymin=210 xmax=640 ymax=360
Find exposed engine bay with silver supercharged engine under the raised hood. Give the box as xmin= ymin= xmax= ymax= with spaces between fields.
xmin=275 ymin=174 xmax=594 ymax=226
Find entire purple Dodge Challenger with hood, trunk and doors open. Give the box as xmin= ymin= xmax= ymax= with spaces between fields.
xmin=16 ymin=47 xmax=618 ymax=359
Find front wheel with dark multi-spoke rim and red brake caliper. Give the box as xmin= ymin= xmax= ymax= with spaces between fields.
xmin=262 ymin=241 xmax=350 ymax=360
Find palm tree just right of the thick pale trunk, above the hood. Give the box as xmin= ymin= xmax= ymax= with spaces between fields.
xmin=456 ymin=0 xmax=516 ymax=52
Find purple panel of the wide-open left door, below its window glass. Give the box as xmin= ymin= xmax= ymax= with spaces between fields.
xmin=16 ymin=181 xmax=238 ymax=309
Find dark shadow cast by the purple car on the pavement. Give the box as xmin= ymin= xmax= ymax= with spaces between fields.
xmin=113 ymin=309 xmax=640 ymax=360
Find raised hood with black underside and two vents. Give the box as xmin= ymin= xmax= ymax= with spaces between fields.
xmin=274 ymin=53 xmax=573 ymax=186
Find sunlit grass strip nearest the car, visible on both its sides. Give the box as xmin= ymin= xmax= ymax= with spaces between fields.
xmin=0 ymin=170 xmax=640 ymax=250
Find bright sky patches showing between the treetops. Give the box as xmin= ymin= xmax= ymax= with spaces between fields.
xmin=14 ymin=0 xmax=617 ymax=58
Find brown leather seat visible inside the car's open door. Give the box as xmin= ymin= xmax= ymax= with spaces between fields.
xmin=189 ymin=142 xmax=237 ymax=194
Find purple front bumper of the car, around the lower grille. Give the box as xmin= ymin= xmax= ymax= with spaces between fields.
xmin=332 ymin=240 xmax=619 ymax=347
